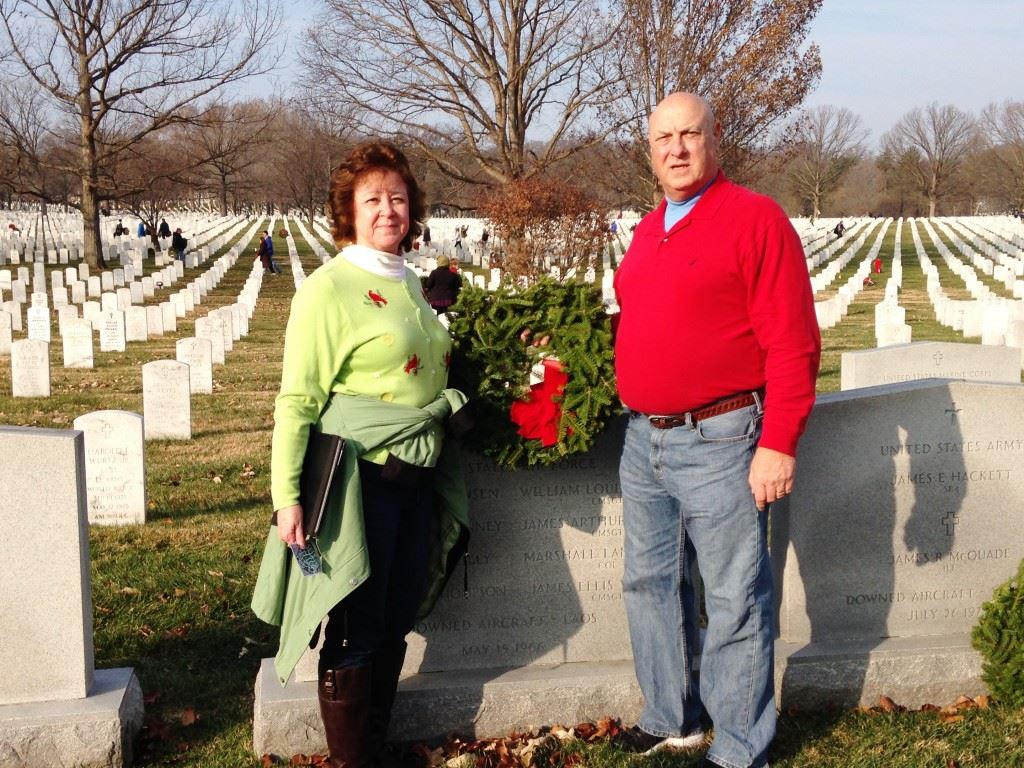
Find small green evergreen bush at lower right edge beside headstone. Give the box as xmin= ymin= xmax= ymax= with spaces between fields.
xmin=972 ymin=560 xmax=1024 ymax=708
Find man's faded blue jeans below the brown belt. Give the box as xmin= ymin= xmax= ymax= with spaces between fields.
xmin=620 ymin=404 xmax=775 ymax=768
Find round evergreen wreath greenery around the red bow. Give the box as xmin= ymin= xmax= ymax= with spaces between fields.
xmin=450 ymin=278 xmax=621 ymax=467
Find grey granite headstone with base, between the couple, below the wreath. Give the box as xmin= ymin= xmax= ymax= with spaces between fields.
xmin=254 ymin=421 xmax=642 ymax=755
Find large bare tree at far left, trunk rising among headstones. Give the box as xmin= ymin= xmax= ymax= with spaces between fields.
xmin=0 ymin=0 xmax=279 ymax=265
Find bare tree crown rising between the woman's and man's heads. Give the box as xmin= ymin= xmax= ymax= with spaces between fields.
xmin=303 ymin=0 xmax=618 ymax=185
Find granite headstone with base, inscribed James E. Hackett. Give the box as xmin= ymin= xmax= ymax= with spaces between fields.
xmin=771 ymin=379 xmax=1024 ymax=708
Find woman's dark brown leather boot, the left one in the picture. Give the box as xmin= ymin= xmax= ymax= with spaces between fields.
xmin=316 ymin=665 xmax=376 ymax=768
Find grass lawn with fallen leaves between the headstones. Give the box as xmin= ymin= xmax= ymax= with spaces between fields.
xmin=0 ymin=222 xmax=1024 ymax=768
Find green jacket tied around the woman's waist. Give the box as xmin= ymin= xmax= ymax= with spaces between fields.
xmin=252 ymin=389 xmax=469 ymax=685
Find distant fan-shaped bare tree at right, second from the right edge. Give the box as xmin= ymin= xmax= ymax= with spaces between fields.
xmin=882 ymin=101 xmax=976 ymax=217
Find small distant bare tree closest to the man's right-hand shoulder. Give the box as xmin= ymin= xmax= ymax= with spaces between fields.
xmin=788 ymin=104 xmax=868 ymax=220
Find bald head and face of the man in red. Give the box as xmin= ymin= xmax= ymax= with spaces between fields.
xmin=648 ymin=94 xmax=721 ymax=202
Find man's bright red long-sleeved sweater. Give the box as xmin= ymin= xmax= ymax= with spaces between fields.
xmin=614 ymin=174 xmax=821 ymax=456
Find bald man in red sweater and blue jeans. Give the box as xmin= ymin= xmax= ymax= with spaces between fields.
xmin=614 ymin=93 xmax=820 ymax=768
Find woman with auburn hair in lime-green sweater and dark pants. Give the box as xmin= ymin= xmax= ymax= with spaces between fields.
xmin=253 ymin=141 xmax=468 ymax=768
